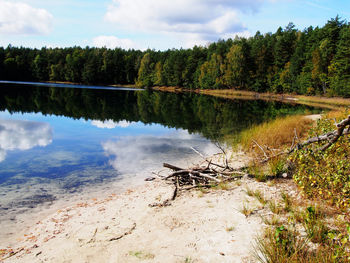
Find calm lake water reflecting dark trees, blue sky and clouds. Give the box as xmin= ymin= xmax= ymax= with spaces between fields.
xmin=0 ymin=82 xmax=319 ymax=244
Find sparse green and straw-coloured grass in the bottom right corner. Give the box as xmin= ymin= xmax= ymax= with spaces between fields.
xmin=254 ymin=192 xmax=350 ymax=263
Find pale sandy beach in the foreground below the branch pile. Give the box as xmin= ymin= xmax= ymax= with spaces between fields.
xmin=1 ymin=151 xmax=300 ymax=262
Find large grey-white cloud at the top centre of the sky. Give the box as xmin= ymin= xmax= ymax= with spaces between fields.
xmin=105 ymin=0 xmax=267 ymax=44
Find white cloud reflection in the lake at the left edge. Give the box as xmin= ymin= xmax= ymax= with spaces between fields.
xmin=0 ymin=119 xmax=52 ymax=162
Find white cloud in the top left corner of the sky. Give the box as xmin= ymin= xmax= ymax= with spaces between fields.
xmin=0 ymin=0 xmax=53 ymax=35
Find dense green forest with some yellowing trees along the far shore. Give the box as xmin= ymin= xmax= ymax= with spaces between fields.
xmin=0 ymin=16 xmax=350 ymax=97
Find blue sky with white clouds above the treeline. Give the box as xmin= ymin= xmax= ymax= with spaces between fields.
xmin=0 ymin=0 xmax=350 ymax=50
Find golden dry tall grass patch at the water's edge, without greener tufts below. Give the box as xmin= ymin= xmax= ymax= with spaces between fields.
xmin=240 ymin=115 xmax=313 ymax=150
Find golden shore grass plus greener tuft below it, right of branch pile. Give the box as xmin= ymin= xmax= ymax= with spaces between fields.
xmin=237 ymin=115 xmax=313 ymax=182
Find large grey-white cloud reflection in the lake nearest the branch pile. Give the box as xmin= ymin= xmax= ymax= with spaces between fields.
xmin=102 ymin=130 xmax=217 ymax=174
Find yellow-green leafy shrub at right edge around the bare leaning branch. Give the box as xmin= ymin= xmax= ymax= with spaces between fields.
xmin=292 ymin=110 xmax=350 ymax=209
